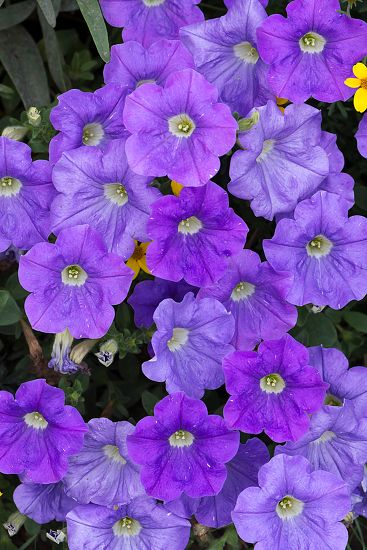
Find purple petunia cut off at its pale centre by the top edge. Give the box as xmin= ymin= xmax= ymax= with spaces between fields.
xmin=100 ymin=0 xmax=204 ymax=47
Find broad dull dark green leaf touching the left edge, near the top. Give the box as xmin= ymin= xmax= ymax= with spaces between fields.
xmin=0 ymin=25 xmax=50 ymax=109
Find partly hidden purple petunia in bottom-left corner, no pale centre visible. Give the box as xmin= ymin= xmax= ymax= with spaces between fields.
xmin=13 ymin=481 xmax=78 ymax=525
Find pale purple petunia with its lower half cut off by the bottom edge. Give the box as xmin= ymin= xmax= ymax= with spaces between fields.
xmin=66 ymin=496 xmax=190 ymax=550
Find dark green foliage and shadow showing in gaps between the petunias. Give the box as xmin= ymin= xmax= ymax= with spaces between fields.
xmin=0 ymin=0 xmax=367 ymax=550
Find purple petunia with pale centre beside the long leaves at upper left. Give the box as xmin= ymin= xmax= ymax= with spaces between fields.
xmin=50 ymin=84 xmax=129 ymax=164
